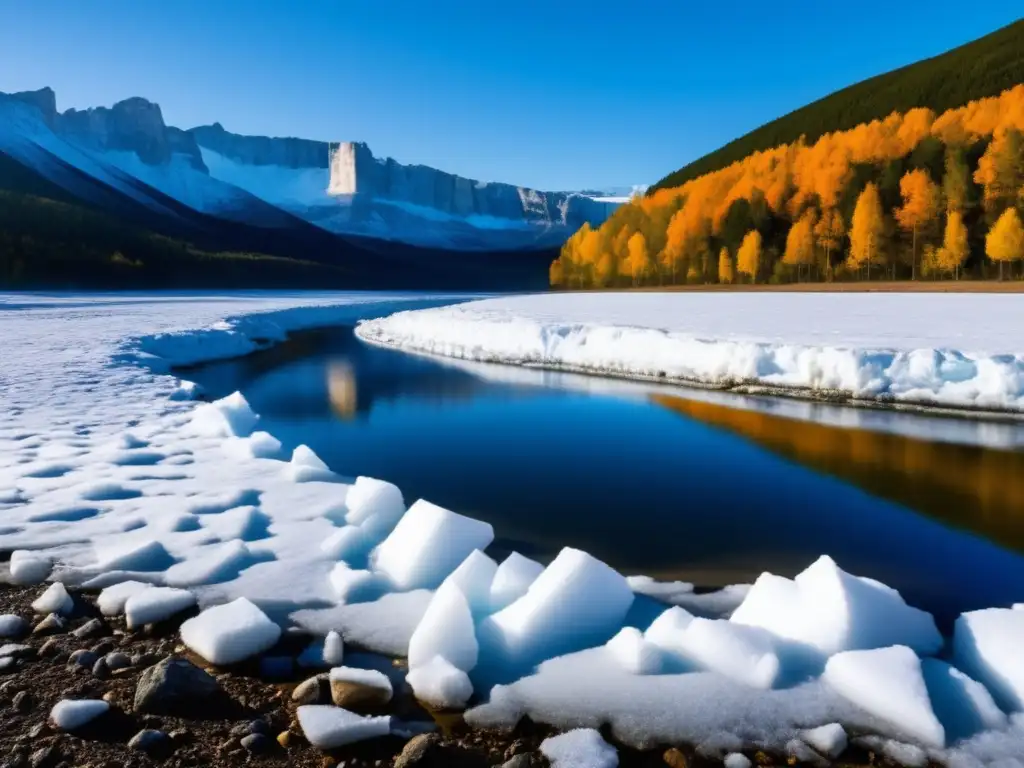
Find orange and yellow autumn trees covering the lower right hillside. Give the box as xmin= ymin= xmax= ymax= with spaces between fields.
xmin=551 ymin=81 xmax=1024 ymax=288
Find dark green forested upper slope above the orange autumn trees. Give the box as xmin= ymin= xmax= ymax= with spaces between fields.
xmin=650 ymin=19 xmax=1024 ymax=193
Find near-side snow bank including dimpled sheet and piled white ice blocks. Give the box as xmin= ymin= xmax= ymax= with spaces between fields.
xmin=6 ymin=294 xmax=1024 ymax=768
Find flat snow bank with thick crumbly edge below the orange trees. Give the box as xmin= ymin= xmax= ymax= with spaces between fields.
xmin=357 ymin=293 xmax=1024 ymax=412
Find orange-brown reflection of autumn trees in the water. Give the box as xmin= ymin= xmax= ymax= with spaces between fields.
xmin=651 ymin=394 xmax=1024 ymax=551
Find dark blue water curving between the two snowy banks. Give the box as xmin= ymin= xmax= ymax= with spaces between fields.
xmin=187 ymin=328 xmax=1024 ymax=618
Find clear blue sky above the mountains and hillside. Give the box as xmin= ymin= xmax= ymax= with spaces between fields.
xmin=0 ymin=0 xmax=1022 ymax=189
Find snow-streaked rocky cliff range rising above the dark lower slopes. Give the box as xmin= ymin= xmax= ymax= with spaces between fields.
xmin=0 ymin=88 xmax=623 ymax=250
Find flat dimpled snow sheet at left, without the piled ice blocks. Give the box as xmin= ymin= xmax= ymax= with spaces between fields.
xmin=0 ymin=292 xmax=456 ymax=618
